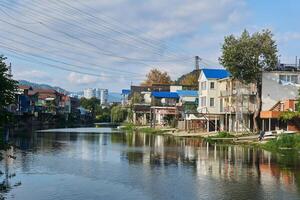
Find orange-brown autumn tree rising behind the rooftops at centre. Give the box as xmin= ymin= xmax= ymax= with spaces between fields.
xmin=141 ymin=69 xmax=172 ymax=85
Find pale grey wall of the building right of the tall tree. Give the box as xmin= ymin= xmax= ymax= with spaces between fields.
xmin=262 ymin=71 xmax=300 ymax=111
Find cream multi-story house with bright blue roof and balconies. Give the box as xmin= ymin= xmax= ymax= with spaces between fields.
xmin=197 ymin=69 xmax=256 ymax=131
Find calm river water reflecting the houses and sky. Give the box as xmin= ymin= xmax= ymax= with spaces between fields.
xmin=0 ymin=128 xmax=300 ymax=200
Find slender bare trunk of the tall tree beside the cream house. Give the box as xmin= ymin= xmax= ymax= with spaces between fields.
xmin=253 ymin=80 xmax=262 ymax=132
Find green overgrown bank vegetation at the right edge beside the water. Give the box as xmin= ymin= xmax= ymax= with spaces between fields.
xmin=262 ymin=135 xmax=300 ymax=151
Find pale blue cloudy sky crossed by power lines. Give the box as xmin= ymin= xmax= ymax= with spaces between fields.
xmin=0 ymin=0 xmax=300 ymax=92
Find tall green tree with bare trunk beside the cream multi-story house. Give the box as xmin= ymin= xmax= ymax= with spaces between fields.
xmin=219 ymin=30 xmax=277 ymax=131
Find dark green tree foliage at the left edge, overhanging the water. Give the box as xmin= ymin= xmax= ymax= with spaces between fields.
xmin=0 ymin=55 xmax=18 ymax=125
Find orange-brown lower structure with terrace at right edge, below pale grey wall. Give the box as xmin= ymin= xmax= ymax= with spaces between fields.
xmin=260 ymin=99 xmax=300 ymax=132
